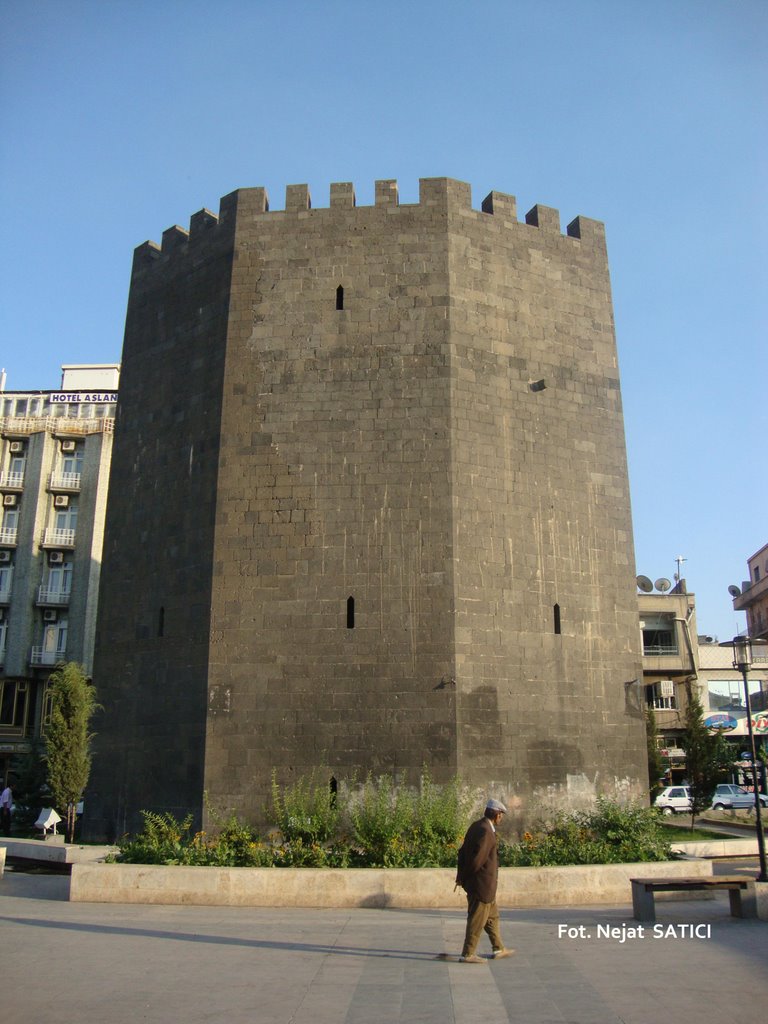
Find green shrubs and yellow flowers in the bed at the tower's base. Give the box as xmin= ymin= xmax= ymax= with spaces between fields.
xmin=117 ymin=786 xmax=673 ymax=867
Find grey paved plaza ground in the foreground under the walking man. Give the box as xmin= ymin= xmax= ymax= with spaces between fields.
xmin=0 ymin=871 xmax=768 ymax=1024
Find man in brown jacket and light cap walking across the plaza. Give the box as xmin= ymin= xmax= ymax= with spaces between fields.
xmin=456 ymin=800 xmax=514 ymax=964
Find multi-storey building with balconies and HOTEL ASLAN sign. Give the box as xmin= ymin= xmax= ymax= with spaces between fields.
xmin=0 ymin=364 xmax=120 ymax=779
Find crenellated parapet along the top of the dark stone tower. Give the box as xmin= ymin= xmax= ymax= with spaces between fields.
xmin=134 ymin=177 xmax=605 ymax=269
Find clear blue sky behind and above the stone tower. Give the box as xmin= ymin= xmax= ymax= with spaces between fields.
xmin=0 ymin=0 xmax=768 ymax=639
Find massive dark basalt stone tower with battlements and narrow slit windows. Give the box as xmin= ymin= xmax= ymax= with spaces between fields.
xmin=87 ymin=178 xmax=647 ymax=835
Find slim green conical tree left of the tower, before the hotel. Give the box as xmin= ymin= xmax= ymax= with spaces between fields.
xmin=45 ymin=662 xmax=98 ymax=843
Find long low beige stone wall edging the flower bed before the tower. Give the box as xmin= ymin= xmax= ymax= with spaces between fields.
xmin=70 ymin=860 xmax=712 ymax=909
